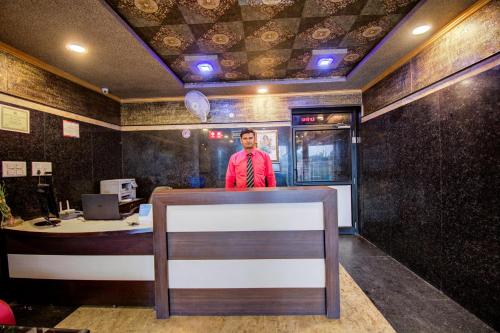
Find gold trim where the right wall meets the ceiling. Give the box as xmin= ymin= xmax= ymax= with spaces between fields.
xmin=362 ymin=0 xmax=491 ymax=92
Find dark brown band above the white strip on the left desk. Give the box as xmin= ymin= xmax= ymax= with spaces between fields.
xmin=5 ymin=232 xmax=153 ymax=255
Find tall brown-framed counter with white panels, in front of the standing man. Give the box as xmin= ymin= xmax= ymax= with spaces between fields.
xmin=153 ymin=187 xmax=340 ymax=318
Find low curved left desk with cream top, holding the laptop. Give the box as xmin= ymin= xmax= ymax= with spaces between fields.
xmin=2 ymin=214 xmax=154 ymax=305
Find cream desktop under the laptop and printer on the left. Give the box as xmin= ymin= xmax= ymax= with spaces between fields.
xmin=3 ymin=214 xmax=153 ymax=236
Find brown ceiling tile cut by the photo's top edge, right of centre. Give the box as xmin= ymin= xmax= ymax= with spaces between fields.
xmin=303 ymin=0 xmax=367 ymax=17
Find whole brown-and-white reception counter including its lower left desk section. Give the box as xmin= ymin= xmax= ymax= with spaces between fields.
xmin=1 ymin=187 xmax=340 ymax=318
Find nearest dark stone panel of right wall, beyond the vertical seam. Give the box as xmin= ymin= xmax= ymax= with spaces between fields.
xmin=439 ymin=67 xmax=500 ymax=329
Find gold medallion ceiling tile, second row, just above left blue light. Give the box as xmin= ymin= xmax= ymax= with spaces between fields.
xmin=195 ymin=22 xmax=245 ymax=53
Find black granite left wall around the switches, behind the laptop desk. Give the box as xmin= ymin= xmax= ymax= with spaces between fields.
xmin=0 ymin=104 xmax=122 ymax=219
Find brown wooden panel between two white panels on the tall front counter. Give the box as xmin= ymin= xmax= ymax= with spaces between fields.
xmin=167 ymin=230 xmax=325 ymax=260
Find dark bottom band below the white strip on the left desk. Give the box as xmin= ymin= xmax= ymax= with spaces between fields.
xmin=9 ymin=279 xmax=154 ymax=306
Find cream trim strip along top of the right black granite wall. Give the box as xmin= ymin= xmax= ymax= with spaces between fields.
xmin=361 ymin=53 xmax=500 ymax=123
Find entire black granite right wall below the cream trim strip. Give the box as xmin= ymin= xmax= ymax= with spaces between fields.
xmin=360 ymin=66 xmax=500 ymax=330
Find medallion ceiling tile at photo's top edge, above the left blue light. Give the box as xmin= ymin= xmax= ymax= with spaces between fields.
xmin=177 ymin=0 xmax=241 ymax=24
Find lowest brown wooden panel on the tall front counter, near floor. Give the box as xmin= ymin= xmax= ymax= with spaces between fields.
xmin=169 ymin=288 xmax=326 ymax=316
